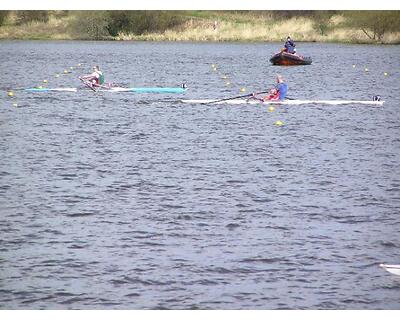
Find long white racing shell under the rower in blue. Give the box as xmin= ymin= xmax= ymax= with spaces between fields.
xmin=181 ymin=99 xmax=384 ymax=106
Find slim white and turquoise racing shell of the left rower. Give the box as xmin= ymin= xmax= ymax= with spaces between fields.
xmin=23 ymin=87 xmax=186 ymax=93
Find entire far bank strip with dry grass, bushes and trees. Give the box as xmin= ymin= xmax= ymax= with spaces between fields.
xmin=0 ymin=10 xmax=400 ymax=44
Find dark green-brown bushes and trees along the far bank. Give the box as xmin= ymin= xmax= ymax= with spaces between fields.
xmin=0 ymin=10 xmax=400 ymax=41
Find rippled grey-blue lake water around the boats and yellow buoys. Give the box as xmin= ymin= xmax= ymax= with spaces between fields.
xmin=0 ymin=41 xmax=400 ymax=309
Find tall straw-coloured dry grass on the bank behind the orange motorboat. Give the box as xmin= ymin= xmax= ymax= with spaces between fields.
xmin=116 ymin=16 xmax=400 ymax=43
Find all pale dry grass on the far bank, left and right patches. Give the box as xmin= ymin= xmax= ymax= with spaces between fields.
xmin=0 ymin=12 xmax=400 ymax=43
